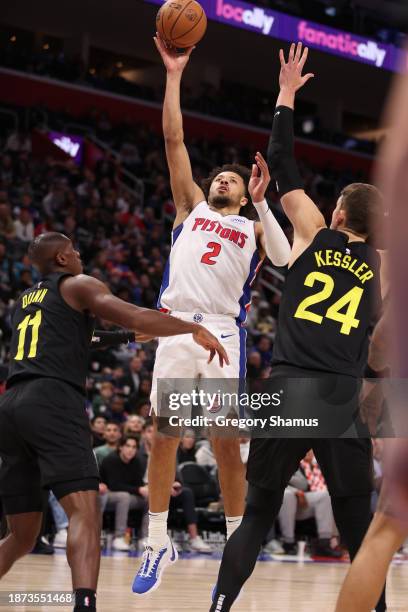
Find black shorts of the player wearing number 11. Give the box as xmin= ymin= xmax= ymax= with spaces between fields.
xmin=0 ymin=378 xmax=99 ymax=513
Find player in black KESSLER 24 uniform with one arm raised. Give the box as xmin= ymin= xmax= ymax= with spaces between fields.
xmin=211 ymin=43 xmax=386 ymax=612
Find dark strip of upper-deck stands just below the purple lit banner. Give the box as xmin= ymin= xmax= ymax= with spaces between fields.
xmin=0 ymin=44 xmax=376 ymax=154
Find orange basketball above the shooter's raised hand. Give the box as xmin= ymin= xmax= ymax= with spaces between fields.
xmin=156 ymin=0 xmax=207 ymax=49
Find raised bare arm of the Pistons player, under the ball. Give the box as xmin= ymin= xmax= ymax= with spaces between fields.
xmin=154 ymin=34 xmax=204 ymax=225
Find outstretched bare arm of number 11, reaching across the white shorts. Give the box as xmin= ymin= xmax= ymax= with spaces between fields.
xmin=61 ymin=274 xmax=229 ymax=365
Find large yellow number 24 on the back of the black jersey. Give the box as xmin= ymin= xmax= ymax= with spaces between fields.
xmin=294 ymin=272 xmax=363 ymax=336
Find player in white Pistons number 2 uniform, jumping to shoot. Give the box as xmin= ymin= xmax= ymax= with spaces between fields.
xmin=133 ymin=35 xmax=290 ymax=595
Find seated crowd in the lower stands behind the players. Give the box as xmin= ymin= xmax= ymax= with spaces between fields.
xmin=0 ymin=98 xmax=376 ymax=552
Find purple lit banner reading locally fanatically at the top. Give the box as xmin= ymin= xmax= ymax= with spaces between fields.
xmin=146 ymin=0 xmax=407 ymax=71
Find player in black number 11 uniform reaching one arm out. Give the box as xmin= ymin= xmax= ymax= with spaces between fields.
xmin=0 ymin=232 xmax=228 ymax=612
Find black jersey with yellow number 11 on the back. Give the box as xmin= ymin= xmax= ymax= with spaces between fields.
xmin=7 ymin=273 xmax=94 ymax=392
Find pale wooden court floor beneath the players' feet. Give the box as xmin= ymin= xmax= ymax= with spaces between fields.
xmin=0 ymin=554 xmax=408 ymax=612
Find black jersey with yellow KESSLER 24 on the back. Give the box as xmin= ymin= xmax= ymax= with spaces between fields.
xmin=272 ymin=228 xmax=381 ymax=377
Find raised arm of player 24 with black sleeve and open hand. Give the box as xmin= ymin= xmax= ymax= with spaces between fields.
xmin=268 ymin=43 xmax=326 ymax=249
